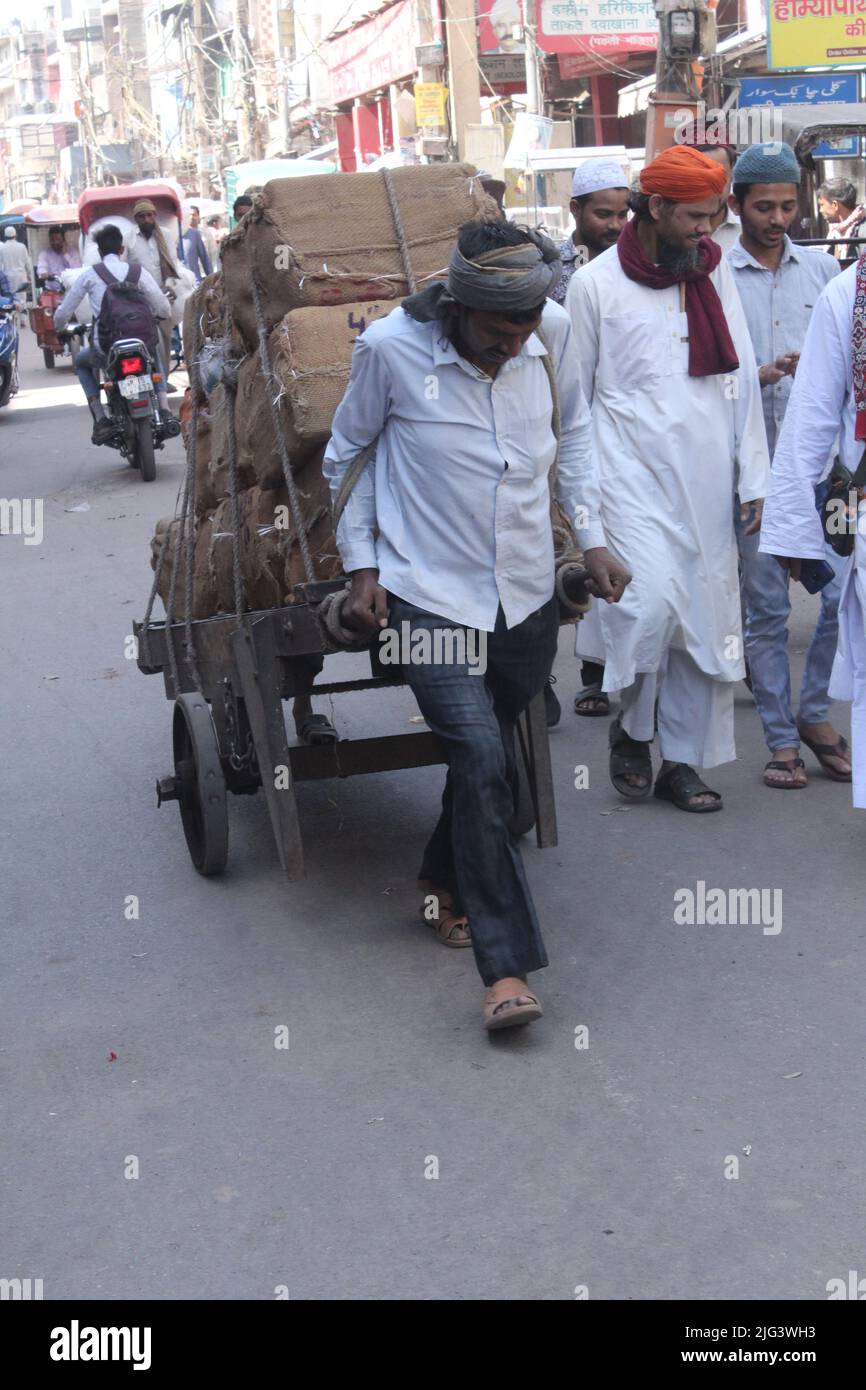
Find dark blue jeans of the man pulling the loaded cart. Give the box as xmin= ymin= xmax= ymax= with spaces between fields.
xmin=389 ymin=595 xmax=559 ymax=986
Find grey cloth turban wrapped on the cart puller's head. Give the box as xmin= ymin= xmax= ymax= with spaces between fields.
xmin=403 ymin=227 xmax=562 ymax=322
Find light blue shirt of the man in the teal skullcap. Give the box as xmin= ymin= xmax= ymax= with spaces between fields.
xmin=727 ymin=236 xmax=840 ymax=457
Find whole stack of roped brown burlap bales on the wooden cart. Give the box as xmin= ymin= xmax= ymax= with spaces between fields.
xmin=152 ymin=164 xmax=500 ymax=619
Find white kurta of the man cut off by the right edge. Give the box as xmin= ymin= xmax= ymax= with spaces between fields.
xmin=760 ymin=261 xmax=866 ymax=809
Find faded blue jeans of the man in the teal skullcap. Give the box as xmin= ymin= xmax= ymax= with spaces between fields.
xmin=735 ymin=507 xmax=849 ymax=752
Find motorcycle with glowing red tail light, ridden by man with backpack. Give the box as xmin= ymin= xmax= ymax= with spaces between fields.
xmin=61 ymin=324 xmax=164 ymax=482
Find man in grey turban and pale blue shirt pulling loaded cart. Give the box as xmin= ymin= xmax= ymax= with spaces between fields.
xmin=324 ymin=222 xmax=630 ymax=1029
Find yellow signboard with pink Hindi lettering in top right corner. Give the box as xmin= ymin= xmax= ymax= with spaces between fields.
xmin=767 ymin=0 xmax=866 ymax=70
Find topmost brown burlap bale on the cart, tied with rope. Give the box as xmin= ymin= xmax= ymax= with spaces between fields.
xmin=220 ymin=164 xmax=500 ymax=350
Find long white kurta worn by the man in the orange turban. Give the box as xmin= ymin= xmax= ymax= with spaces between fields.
xmin=566 ymin=246 xmax=770 ymax=691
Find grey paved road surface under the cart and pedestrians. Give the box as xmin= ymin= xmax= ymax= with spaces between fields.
xmin=0 ymin=334 xmax=866 ymax=1300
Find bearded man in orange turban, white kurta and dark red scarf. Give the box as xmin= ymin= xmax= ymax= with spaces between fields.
xmin=566 ymin=147 xmax=769 ymax=810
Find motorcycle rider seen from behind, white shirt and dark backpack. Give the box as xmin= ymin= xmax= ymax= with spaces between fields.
xmin=54 ymin=222 xmax=181 ymax=443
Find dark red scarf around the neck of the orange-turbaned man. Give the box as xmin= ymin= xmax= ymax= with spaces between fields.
xmin=616 ymin=218 xmax=740 ymax=377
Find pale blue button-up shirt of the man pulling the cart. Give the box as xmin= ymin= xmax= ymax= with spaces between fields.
xmin=324 ymin=302 xmax=605 ymax=632
